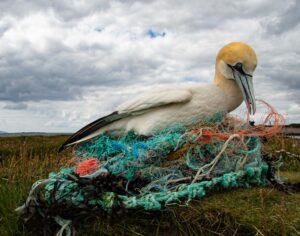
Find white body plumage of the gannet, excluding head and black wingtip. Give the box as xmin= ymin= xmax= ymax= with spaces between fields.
xmin=86 ymin=84 xmax=243 ymax=139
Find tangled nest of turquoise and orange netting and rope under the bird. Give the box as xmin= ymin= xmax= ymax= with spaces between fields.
xmin=18 ymin=99 xmax=283 ymax=234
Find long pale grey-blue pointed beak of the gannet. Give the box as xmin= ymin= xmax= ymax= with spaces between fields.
xmin=232 ymin=67 xmax=256 ymax=115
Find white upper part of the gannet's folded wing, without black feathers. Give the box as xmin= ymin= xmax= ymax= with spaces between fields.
xmin=117 ymin=88 xmax=192 ymax=114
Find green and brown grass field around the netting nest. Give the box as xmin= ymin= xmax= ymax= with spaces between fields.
xmin=0 ymin=136 xmax=300 ymax=236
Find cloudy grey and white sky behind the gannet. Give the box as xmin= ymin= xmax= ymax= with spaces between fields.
xmin=0 ymin=0 xmax=300 ymax=132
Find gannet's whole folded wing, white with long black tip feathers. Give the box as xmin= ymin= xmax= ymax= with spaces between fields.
xmin=59 ymin=88 xmax=192 ymax=152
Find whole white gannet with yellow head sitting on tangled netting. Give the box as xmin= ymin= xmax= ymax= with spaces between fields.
xmin=59 ymin=42 xmax=257 ymax=152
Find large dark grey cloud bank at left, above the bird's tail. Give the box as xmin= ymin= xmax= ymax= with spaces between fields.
xmin=0 ymin=37 xmax=159 ymax=102
